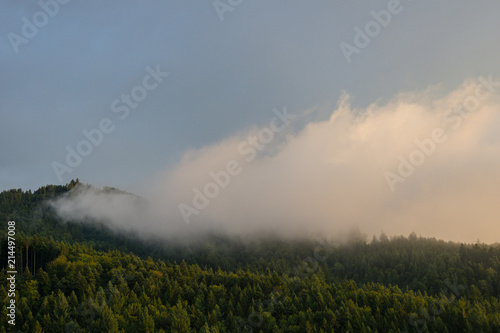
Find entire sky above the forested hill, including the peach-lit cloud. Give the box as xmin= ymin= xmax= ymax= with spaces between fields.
xmin=0 ymin=0 xmax=500 ymax=242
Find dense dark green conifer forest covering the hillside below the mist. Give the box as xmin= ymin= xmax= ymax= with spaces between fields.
xmin=0 ymin=180 xmax=500 ymax=333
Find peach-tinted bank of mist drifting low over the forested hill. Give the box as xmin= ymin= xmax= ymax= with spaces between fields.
xmin=51 ymin=76 xmax=500 ymax=243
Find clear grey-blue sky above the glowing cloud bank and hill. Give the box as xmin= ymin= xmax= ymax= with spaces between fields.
xmin=0 ymin=0 xmax=500 ymax=190
